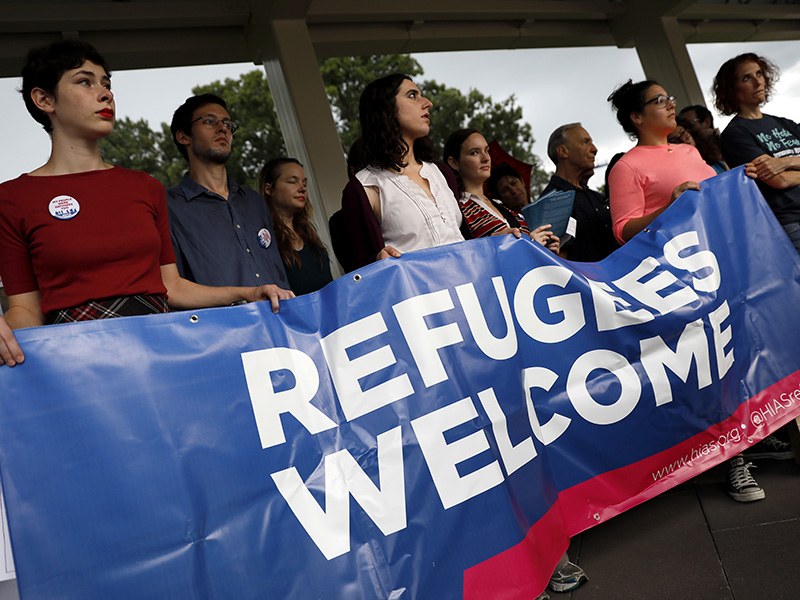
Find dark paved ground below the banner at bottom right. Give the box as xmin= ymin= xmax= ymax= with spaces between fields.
xmin=564 ymin=460 xmax=800 ymax=600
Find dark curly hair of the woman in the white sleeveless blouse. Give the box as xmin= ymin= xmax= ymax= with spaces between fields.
xmin=358 ymin=73 xmax=439 ymax=171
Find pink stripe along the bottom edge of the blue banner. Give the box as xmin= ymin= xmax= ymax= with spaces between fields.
xmin=464 ymin=371 xmax=800 ymax=600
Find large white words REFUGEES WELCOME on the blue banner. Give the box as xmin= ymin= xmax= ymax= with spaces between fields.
xmin=242 ymin=231 xmax=740 ymax=559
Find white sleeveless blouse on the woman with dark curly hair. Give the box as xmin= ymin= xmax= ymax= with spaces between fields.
xmin=356 ymin=162 xmax=464 ymax=252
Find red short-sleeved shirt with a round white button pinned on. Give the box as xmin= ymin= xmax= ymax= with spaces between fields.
xmin=0 ymin=167 xmax=175 ymax=315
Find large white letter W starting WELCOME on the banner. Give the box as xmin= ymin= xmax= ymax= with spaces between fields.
xmin=272 ymin=427 xmax=407 ymax=560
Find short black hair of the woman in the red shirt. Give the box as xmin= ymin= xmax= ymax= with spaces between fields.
xmin=19 ymin=40 xmax=111 ymax=134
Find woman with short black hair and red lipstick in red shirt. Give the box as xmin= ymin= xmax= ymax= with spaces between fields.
xmin=0 ymin=40 xmax=292 ymax=352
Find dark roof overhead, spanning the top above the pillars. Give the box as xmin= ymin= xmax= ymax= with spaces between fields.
xmin=0 ymin=0 xmax=800 ymax=77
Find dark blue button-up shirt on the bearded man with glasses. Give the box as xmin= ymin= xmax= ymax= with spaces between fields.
xmin=167 ymin=173 xmax=289 ymax=290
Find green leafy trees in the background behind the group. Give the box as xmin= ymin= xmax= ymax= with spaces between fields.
xmin=100 ymin=54 xmax=548 ymax=191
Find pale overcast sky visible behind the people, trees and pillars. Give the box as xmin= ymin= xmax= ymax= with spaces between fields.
xmin=0 ymin=42 xmax=800 ymax=187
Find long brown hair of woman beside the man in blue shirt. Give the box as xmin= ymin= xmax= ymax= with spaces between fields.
xmin=258 ymin=158 xmax=325 ymax=268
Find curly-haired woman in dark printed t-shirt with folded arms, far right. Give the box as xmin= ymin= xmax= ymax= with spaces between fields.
xmin=713 ymin=52 xmax=800 ymax=252
